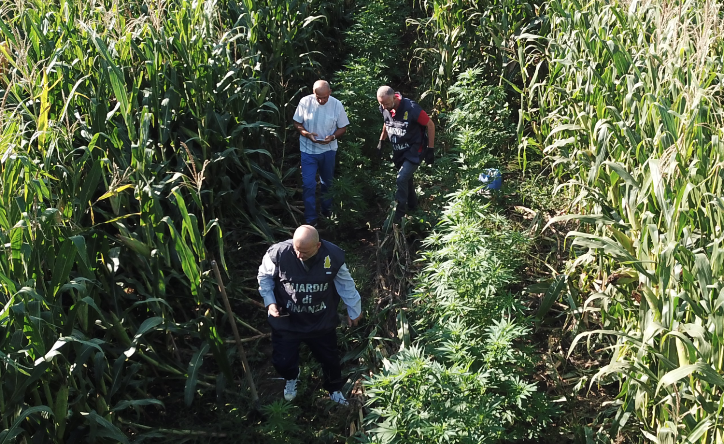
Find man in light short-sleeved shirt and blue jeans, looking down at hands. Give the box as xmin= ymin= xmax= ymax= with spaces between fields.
xmin=293 ymin=80 xmax=349 ymax=226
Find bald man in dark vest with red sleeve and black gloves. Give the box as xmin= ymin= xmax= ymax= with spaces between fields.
xmin=377 ymin=86 xmax=435 ymax=222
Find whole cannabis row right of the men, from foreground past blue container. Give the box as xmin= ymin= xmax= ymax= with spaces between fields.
xmin=365 ymin=66 xmax=556 ymax=443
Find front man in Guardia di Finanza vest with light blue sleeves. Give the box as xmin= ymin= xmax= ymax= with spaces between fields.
xmin=257 ymin=225 xmax=362 ymax=405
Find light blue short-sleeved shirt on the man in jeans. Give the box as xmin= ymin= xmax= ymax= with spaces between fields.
xmin=293 ymin=94 xmax=349 ymax=154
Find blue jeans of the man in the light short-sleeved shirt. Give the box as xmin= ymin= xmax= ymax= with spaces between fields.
xmin=302 ymin=150 xmax=337 ymax=224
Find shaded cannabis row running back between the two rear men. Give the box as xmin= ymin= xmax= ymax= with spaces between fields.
xmin=331 ymin=0 xmax=409 ymax=225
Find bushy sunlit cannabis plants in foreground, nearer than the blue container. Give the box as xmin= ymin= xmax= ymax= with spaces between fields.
xmin=366 ymin=193 xmax=553 ymax=443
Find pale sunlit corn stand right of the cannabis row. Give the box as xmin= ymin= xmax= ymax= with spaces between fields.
xmin=521 ymin=1 xmax=724 ymax=443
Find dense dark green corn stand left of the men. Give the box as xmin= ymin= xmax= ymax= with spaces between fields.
xmin=0 ymin=0 xmax=348 ymax=442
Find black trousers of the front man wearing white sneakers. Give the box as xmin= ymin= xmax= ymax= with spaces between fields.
xmin=272 ymin=330 xmax=345 ymax=393
